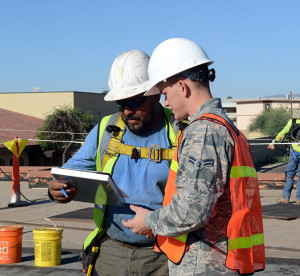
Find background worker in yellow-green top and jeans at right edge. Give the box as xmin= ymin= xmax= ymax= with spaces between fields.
xmin=268 ymin=118 xmax=300 ymax=205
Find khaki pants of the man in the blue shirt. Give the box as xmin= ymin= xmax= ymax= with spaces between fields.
xmin=93 ymin=239 xmax=169 ymax=276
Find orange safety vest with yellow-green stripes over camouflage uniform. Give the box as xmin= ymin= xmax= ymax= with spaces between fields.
xmin=155 ymin=113 xmax=265 ymax=274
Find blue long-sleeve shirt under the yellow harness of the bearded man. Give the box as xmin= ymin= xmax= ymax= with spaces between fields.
xmin=63 ymin=117 xmax=170 ymax=244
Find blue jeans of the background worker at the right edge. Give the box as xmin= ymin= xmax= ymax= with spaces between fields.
xmin=282 ymin=150 xmax=300 ymax=200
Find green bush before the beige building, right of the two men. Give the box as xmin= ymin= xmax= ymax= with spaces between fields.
xmin=249 ymin=107 xmax=291 ymax=137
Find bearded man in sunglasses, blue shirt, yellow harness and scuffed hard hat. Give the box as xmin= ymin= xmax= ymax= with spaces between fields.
xmin=49 ymin=50 xmax=186 ymax=275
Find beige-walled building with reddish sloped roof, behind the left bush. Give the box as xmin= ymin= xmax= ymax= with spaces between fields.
xmin=0 ymin=91 xmax=118 ymax=166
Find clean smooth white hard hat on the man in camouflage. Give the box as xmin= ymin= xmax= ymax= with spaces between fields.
xmin=145 ymin=38 xmax=213 ymax=96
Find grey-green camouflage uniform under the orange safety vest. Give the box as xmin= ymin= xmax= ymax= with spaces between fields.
xmin=145 ymin=98 xmax=236 ymax=275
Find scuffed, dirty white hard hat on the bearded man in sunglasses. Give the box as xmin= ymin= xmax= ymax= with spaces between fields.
xmin=104 ymin=50 xmax=150 ymax=101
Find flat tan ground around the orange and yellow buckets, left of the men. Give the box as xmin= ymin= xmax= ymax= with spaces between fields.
xmin=0 ymin=181 xmax=95 ymax=276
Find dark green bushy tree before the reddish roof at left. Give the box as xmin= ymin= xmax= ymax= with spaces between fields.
xmin=37 ymin=106 xmax=94 ymax=151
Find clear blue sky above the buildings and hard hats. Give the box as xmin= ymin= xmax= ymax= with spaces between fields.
xmin=0 ymin=0 xmax=300 ymax=98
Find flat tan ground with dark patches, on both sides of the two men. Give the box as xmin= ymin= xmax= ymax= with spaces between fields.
xmin=0 ymin=163 xmax=300 ymax=276
